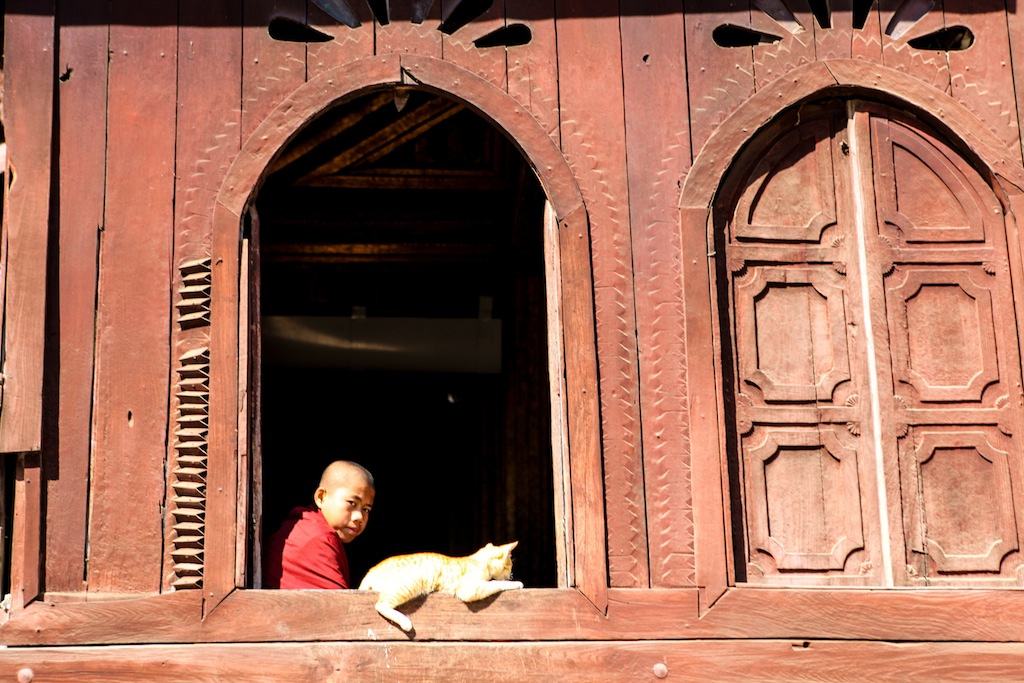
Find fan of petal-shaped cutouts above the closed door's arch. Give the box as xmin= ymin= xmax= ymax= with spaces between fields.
xmin=712 ymin=0 xmax=974 ymax=52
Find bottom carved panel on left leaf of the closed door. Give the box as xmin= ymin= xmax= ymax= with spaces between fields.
xmin=743 ymin=427 xmax=864 ymax=574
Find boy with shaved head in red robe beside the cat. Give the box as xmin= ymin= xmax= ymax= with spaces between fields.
xmin=263 ymin=460 xmax=375 ymax=589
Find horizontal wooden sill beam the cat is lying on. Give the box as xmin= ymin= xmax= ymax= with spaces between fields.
xmin=9 ymin=588 xmax=1024 ymax=651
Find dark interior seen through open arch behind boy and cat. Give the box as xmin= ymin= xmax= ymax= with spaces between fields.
xmin=257 ymin=89 xmax=557 ymax=587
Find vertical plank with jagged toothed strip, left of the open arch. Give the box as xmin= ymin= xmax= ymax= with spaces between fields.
xmin=163 ymin=0 xmax=245 ymax=590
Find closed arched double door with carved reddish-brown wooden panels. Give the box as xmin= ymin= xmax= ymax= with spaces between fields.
xmin=716 ymin=101 xmax=1024 ymax=586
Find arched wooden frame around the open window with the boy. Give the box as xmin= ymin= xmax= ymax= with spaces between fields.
xmin=204 ymin=54 xmax=608 ymax=613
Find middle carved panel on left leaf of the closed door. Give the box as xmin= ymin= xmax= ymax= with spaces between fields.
xmin=734 ymin=265 xmax=850 ymax=403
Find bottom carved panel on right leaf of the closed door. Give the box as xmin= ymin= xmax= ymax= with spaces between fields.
xmin=901 ymin=426 xmax=1020 ymax=579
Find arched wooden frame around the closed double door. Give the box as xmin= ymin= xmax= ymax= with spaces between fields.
xmin=679 ymin=59 xmax=1024 ymax=611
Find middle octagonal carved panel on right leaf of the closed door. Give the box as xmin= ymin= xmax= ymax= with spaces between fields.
xmin=887 ymin=266 xmax=1006 ymax=403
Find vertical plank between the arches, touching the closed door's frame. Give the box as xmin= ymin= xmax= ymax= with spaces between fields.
xmin=608 ymin=0 xmax=693 ymax=587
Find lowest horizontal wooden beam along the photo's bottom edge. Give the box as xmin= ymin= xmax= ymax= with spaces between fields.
xmin=6 ymin=640 xmax=1024 ymax=683
